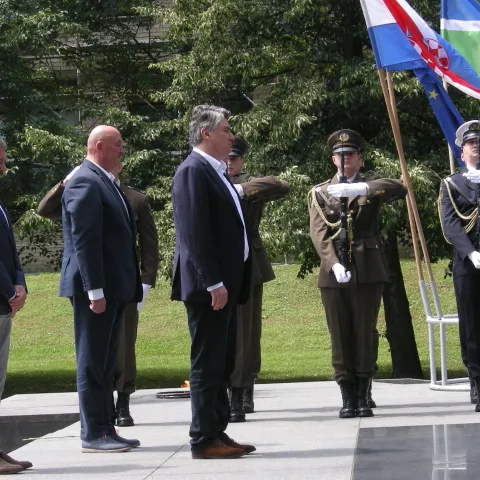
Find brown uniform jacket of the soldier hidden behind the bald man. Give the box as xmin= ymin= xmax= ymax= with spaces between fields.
xmin=37 ymin=182 xmax=159 ymax=287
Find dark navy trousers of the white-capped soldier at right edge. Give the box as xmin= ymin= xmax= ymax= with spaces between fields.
xmin=453 ymin=272 xmax=480 ymax=378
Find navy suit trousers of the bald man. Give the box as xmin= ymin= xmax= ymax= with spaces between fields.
xmin=71 ymin=295 xmax=125 ymax=441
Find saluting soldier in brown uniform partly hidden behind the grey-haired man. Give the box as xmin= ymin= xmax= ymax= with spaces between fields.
xmin=227 ymin=137 xmax=290 ymax=422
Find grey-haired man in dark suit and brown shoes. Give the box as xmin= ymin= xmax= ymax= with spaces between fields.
xmin=172 ymin=105 xmax=255 ymax=458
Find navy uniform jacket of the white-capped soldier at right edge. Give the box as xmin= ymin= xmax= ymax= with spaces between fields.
xmin=440 ymin=168 xmax=479 ymax=276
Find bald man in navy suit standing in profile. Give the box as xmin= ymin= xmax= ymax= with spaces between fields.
xmin=59 ymin=125 xmax=143 ymax=453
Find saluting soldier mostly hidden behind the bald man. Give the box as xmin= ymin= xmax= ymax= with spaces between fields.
xmin=37 ymin=164 xmax=158 ymax=427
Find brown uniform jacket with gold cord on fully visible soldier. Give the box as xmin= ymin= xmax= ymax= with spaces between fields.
xmin=308 ymin=173 xmax=407 ymax=288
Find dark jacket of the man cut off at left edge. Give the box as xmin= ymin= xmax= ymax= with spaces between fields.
xmin=0 ymin=202 xmax=27 ymax=315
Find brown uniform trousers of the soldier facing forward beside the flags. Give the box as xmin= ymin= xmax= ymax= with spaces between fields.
xmin=320 ymin=276 xmax=383 ymax=383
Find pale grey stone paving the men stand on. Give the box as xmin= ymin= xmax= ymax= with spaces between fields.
xmin=0 ymin=382 xmax=480 ymax=480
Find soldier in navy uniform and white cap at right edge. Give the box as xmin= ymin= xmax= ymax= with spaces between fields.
xmin=439 ymin=120 xmax=480 ymax=412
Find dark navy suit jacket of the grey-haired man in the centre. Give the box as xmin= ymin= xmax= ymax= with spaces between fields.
xmin=172 ymin=152 xmax=251 ymax=303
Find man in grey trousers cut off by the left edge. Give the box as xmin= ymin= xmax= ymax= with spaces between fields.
xmin=0 ymin=137 xmax=32 ymax=475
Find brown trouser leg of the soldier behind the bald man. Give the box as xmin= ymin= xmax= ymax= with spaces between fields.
xmin=115 ymin=303 xmax=138 ymax=394
